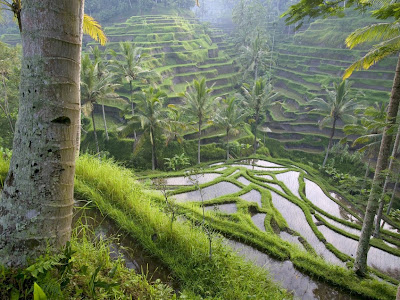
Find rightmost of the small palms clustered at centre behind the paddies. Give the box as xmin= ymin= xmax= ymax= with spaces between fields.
xmin=242 ymin=78 xmax=278 ymax=154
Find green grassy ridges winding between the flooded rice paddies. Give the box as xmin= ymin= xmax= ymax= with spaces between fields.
xmin=138 ymin=159 xmax=399 ymax=299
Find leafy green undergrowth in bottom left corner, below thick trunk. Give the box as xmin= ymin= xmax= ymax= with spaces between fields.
xmin=0 ymin=219 xmax=176 ymax=300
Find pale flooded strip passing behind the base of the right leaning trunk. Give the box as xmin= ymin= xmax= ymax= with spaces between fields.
xmin=318 ymin=225 xmax=400 ymax=279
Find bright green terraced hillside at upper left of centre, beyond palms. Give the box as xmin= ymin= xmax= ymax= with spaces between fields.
xmin=87 ymin=15 xmax=238 ymax=103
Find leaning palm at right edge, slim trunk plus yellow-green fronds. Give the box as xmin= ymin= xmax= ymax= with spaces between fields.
xmin=344 ymin=9 xmax=400 ymax=276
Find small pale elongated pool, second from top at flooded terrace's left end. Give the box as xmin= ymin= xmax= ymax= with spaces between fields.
xmin=173 ymin=181 xmax=240 ymax=202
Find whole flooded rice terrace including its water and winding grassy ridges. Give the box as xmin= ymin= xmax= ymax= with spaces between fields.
xmin=142 ymin=159 xmax=400 ymax=299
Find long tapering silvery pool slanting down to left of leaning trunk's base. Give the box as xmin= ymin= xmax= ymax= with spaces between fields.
xmin=271 ymin=192 xmax=344 ymax=266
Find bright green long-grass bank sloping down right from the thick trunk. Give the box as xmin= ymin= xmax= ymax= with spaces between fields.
xmin=75 ymin=156 xmax=290 ymax=299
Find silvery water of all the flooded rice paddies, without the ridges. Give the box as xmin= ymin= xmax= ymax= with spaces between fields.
xmin=148 ymin=159 xmax=400 ymax=299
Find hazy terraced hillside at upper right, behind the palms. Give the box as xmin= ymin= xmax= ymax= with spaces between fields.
xmin=265 ymin=16 xmax=397 ymax=153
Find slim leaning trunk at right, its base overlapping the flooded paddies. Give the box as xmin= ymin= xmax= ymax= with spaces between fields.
xmin=354 ymin=52 xmax=400 ymax=276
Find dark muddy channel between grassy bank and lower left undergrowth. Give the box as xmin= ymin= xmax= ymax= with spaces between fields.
xmin=72 ymin=208 xmax=173 ymax=289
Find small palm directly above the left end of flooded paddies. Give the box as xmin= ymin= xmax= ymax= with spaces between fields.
xmin=134 ymin=87 xmax=166 ymax=170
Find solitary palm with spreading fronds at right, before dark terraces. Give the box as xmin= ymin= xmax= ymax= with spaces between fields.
xmin=310 ymin=81 xmax=360 ymax=167
